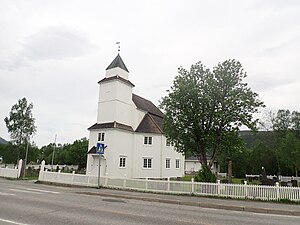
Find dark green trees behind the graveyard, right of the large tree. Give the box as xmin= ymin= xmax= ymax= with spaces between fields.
xmin=218 ymin=109 xmax=300 ymax=177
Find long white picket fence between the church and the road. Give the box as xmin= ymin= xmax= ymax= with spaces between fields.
xmin=39 ymin=171 xmax=300 ymax=202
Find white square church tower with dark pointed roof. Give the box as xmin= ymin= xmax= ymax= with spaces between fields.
xmin=97 ymin=54 xmax=134 ymax=127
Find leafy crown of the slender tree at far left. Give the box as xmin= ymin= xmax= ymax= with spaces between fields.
xmin=4 ymin=98 xmax=36 ymax=144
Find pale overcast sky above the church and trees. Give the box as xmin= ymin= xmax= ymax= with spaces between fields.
xmin=0 ymin=0 xmax=300 ymax=147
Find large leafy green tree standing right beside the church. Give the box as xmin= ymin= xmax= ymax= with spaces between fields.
xmin=160 ymin=60 xmax=264 ymax=171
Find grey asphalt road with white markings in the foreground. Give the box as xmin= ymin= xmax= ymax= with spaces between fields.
xmin=0 ymin=178 xmax=300 ymax=225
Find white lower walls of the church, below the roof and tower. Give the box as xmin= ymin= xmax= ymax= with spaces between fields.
xmin=87 ymin=129 xmax=184 ymax=178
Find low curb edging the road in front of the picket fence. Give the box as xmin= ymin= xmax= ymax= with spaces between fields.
xmin=75 ymin=192 xmax=300 ymax=216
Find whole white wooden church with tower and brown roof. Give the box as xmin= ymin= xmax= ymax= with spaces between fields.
xmin=87 ymin=54 xmax=184 ymax=178
